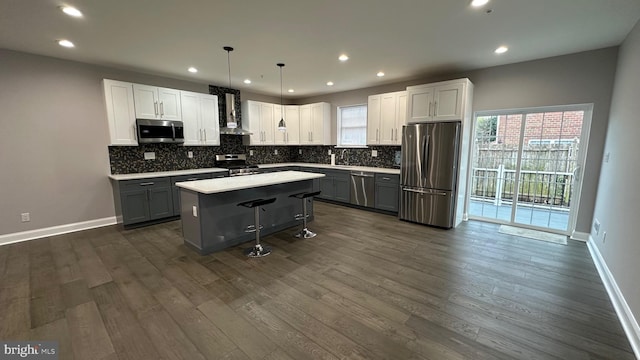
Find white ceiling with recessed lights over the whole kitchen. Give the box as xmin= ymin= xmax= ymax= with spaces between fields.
xmin=0 ymin=0 xmax=640 ymax=97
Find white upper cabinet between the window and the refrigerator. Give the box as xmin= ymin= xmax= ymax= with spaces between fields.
xmin=367 ymin=91 xmax=407 ymax=145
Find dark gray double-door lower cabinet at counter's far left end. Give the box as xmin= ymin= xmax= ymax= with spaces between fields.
xmin=118 ymin=177 xmax=173 ymax=225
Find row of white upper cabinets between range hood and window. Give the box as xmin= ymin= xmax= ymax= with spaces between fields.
xmin=242 ymin=100 xmax=331 ymax=145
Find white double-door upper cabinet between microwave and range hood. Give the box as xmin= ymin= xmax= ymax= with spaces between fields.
xmin=180 ymin=91 xmax=220 ymax=146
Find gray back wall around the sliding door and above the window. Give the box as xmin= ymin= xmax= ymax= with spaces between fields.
xmin=297 ymin=47 xmax=618 ymax=233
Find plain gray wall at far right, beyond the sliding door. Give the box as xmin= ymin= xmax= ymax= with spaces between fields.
xmin=591 ymin=22 xmax=640 ymax=319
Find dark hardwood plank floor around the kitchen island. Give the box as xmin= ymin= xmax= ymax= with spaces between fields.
xmin=0 ymin=202 xmax=635 ymax=360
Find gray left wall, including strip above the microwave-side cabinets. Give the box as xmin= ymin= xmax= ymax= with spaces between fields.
xmin=0 ymin=49 xmax=275 ymax=235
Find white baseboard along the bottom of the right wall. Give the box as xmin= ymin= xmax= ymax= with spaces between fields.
xmin=587 ymin=235 xmax=640 ymax=359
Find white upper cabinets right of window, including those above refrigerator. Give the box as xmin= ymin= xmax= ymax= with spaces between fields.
xmin=367 ymin=79 xmax=473 ymax=145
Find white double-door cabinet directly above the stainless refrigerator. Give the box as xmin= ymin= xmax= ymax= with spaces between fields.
xmin=407 ymin=79 xmax=471 ymax=123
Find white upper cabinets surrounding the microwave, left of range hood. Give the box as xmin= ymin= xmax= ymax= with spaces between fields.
xmin=103 ymin=79 xmax=220 ymax=145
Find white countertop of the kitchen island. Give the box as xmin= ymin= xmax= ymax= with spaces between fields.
xmin=176 ymin=171 xmax=324 ymax=194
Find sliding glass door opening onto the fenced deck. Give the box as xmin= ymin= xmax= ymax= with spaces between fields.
xmin=468 ymin=105 xmax=591 ymax=235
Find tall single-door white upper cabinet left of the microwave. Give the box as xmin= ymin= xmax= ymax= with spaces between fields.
xmin=102 ymin=79 xmax=138 ymax=145
